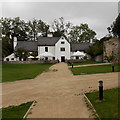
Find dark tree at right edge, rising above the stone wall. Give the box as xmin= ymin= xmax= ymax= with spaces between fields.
xmin=107 ymin=13 xmax=120 ymax=38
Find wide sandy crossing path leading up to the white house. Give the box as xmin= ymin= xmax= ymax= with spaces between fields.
xmin=2 ymin=63 xmax=118 ymax=118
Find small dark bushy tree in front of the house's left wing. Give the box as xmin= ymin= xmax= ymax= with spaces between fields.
xmin=15 ymin=48 xmax=29 ymax=61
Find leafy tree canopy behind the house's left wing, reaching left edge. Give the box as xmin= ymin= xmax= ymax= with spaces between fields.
xmin=0 ymin=17 xmax=49 ymax=41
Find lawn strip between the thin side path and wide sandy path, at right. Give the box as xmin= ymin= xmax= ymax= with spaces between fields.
xmin=70 ymin=65 xmax=119 ymax=75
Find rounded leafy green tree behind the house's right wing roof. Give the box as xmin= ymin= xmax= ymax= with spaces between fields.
xmin=69 ymin=24 xmax=96 ymax=42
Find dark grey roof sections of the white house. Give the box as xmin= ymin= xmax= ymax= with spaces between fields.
xmin=15 ymin=37 xmax=91 ymax=52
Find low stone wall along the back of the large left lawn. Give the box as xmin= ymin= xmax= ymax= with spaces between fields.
xmin=2 ymin=60 xmax=58 ymax=64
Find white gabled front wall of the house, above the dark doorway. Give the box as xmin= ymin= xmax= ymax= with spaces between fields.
xmin=55 ymin=37 xmax=70 ymax=62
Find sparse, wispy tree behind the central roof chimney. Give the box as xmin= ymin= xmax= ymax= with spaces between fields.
xmin=52 ymin=17 xmax=72 ymax=37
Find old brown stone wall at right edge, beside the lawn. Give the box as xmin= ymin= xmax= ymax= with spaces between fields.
xmin=103 ymin=38 xmax=120 ymax=63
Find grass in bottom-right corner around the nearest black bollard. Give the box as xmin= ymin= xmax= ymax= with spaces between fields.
xmin=86 ymin=88 xmax=120 ymax=119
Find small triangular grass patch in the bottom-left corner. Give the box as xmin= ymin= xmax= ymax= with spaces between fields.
xmin=2 ymin=102 xmax=33 ymax=120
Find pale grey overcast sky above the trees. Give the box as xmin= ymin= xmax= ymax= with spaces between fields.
xmin=2 ymin=2 xmax=118 ymax=39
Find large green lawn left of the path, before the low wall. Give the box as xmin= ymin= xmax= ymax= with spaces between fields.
xmin=2 ymin=64 xmax=53 ymax=82
